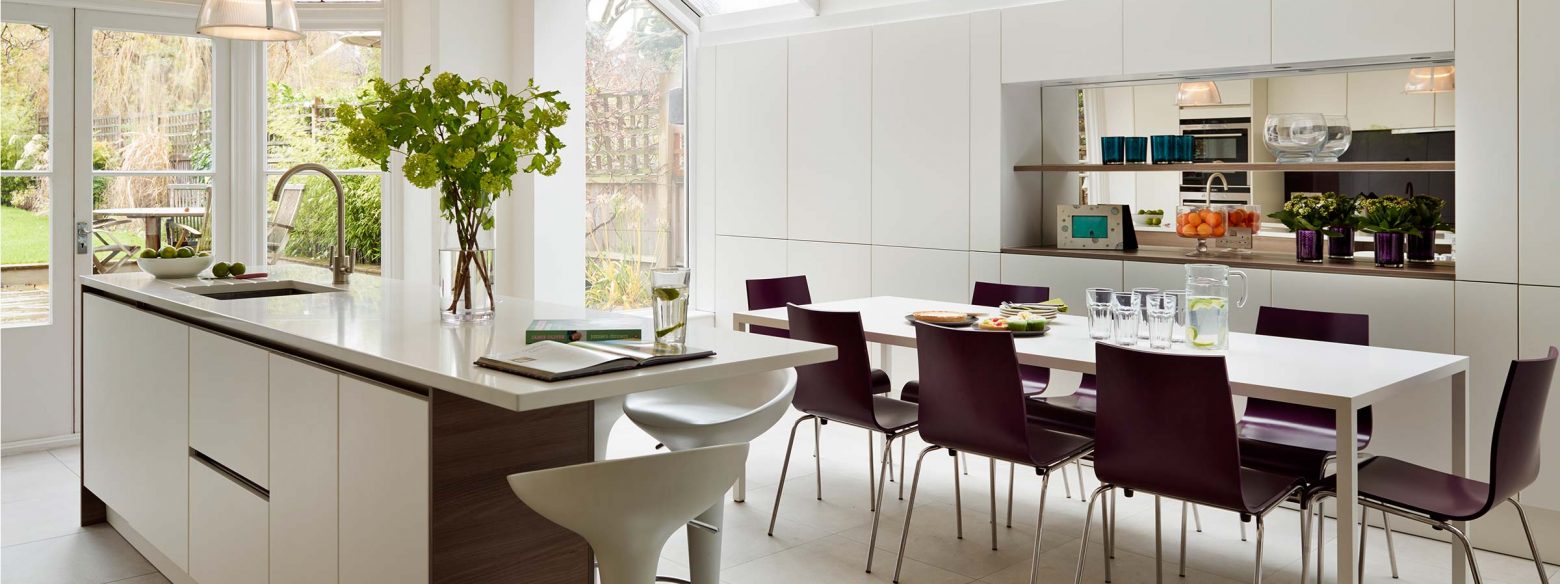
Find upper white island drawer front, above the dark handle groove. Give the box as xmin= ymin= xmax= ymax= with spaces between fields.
xmin=189 ymin=329 xmax=270 ymax=489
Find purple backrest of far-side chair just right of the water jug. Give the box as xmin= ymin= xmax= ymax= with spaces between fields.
xmin=1242 ymin=306 xmax=1374 ymax=442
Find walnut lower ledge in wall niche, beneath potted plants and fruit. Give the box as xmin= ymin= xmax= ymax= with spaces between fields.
xmin=1002 ymin=244 xmax=1457 ymax=280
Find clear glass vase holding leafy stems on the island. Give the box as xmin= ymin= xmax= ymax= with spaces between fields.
xmin=438 ymin=225 xmax=495 ymax=323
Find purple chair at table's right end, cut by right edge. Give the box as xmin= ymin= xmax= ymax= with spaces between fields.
xmin=1301 ymin=347 xmax=1560 ymax=584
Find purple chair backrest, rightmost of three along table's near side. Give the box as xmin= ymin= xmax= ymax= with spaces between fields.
xmin=1094 ymin=344 xmax=1245 ymax=509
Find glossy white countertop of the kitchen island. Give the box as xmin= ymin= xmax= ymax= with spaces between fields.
xmin=81 ymin=265 xmax=835 ymax=411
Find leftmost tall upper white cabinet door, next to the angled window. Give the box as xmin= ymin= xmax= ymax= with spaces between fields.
xmin=714 ymin=39 xmax=788 ymax=237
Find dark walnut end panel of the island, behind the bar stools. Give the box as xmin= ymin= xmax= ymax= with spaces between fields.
xmin=430 ymin=389 xmax=594 ymax=584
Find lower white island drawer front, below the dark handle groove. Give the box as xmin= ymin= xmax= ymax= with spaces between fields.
xmin=189 ymin=458 xmax=268 ymax=584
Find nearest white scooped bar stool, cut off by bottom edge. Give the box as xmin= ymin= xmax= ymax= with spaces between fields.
xmin=509 ymin=443 xmax=747 ymax=584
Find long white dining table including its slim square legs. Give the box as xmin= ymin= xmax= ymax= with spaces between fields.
xmin=732 ymin=297 xmax=1470 ymax=584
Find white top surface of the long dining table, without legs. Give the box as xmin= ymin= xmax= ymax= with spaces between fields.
xmin=733 ymin=297 xmax=1468 ymax=409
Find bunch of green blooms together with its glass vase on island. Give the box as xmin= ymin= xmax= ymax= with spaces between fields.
xmin=337 ymin=69 xmax=569 ymax=320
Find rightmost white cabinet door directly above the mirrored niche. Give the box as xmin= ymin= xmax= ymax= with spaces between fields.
xmin=1273 ymin=0 xmax=1453 ymax=62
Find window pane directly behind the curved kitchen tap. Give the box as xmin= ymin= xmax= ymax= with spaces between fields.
xmin=265 ymin=31 xmax=384 ymax=272
